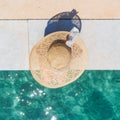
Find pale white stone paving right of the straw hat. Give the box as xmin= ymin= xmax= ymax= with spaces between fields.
xmin=81 ymin=20 xmax=120 ymax=70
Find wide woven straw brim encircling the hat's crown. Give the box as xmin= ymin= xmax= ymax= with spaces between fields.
xmin=30 ymin=31 xmax=88 ymax=88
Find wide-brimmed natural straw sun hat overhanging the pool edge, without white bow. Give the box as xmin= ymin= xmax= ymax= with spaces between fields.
xmin=30 ymin=31 xmax=88 ymax=88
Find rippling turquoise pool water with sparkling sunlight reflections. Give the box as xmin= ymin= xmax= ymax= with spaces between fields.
xmin=0 ymin=70 xmax=120 ymax=120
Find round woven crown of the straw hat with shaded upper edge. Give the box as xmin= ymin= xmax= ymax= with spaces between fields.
xmin=47 ymin=40 xmax=71 ymax=70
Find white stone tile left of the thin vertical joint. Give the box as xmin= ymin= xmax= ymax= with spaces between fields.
xmin=0 ymin=20 xmax=29 ymax=70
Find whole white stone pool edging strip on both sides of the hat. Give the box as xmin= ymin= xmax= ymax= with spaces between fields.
xmin=0 ymin=20 xmax=120 ymax=70
